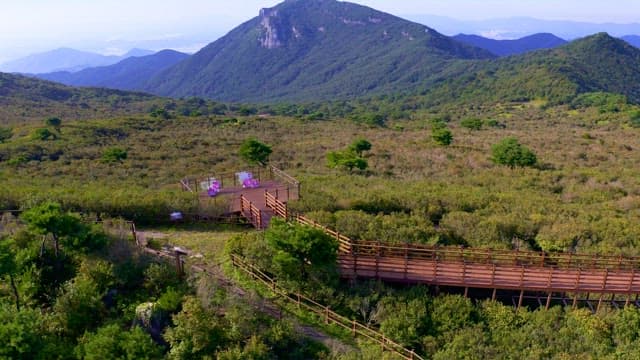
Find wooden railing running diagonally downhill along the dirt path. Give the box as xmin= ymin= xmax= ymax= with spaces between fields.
xmin=231 ymin=254 xmax=423 ymax=360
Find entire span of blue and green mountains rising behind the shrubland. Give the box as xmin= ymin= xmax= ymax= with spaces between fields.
xmin=3 ymin=0 xmax=640 ymax=107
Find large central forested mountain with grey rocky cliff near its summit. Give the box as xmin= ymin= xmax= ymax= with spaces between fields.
xmin=144 ymin=0 xmax=493 ymax=102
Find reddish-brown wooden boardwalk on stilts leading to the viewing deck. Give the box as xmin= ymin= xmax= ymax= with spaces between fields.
xmin=183 ymin=167 xmax=640 ymax=307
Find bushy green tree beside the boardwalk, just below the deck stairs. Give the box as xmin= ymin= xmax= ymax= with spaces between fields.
xmin=265 ymin=219 xmax=338 ymax=287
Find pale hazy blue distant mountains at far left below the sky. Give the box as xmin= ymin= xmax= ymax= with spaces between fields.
xmin=0 ymin=48 xmax=154 ymax=74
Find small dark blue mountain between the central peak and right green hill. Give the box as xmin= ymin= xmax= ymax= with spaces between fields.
xmin=453 ymin=33 xmax=567 ymax=56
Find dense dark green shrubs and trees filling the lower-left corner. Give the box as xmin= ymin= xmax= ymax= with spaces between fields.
xmin=0 ymin=207 xmax=326 ymax=359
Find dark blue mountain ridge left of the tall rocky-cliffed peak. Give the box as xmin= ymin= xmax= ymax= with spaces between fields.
xmin=36 ymin=50 xmax=189 ymax=90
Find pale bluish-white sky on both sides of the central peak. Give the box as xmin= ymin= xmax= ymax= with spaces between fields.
xmin=0 ymin=0 xmax=640 ymax=63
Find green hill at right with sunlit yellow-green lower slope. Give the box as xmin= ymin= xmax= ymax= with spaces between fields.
xmin=428 ymin=33 xmax=640 ymax=104
